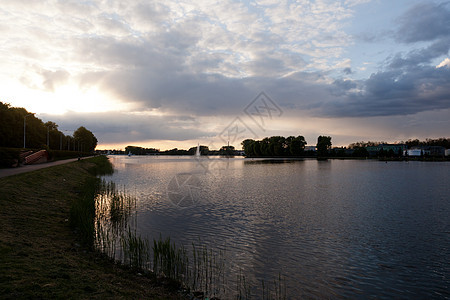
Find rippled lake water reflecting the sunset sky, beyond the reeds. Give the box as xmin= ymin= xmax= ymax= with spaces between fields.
xmin=105 ymin=156 xmax=450 ymax=299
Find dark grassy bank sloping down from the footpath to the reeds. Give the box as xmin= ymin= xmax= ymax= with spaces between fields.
xmin=0 ymin=157 xmax=180 ymax=299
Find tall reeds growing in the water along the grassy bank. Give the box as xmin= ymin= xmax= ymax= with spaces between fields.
xmin=70 ymin=158 xmax=286 ymax=300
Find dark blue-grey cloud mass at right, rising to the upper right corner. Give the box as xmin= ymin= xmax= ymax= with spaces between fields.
xmin=315 ymin=2 xmax=450 ymax=117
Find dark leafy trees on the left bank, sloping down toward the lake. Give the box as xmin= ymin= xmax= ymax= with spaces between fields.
xmin=0 ymin=102 xmax=98 ymax=152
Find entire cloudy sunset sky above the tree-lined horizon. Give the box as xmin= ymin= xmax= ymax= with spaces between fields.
xmin=0 ymin=0 xmax=450 ymax=150
